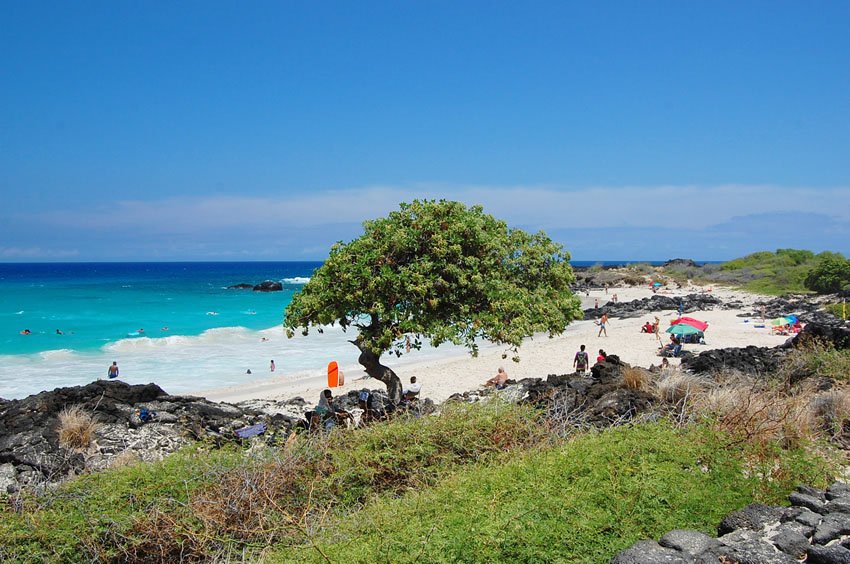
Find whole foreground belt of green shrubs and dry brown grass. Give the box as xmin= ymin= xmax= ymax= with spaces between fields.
xmin=0 ymin=368 xmax=850 ymax=562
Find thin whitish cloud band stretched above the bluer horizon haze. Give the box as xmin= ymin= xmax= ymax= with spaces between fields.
xmin=26 ymin=184 xmax=850 ymax=234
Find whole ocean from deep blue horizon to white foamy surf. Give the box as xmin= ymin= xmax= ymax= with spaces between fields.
xmin=0 ymin=261 xmax=664 ymax=399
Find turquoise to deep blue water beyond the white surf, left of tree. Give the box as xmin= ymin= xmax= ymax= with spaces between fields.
xmin=0 ymin=262 xmax=321 ymax=354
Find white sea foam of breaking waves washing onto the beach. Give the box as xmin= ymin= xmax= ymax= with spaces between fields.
xmin=0 ymin=325 xmax=474 ymax=399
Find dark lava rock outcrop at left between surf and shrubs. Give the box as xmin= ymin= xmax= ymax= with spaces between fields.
xmin=0 ymin=380 xmax=291 ymax=490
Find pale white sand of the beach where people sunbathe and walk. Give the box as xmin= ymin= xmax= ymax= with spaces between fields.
xmin=198 ymin=287 xmax=790 ymax=403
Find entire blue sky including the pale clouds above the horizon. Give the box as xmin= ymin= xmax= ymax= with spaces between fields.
xmin=0 ymin=0 xmax=850 ymax=261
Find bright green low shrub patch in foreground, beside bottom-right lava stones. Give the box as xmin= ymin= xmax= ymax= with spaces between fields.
xmin=269 ymin=423 xmax=832 ymax=562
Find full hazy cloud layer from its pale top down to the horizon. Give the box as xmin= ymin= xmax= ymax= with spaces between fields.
xmin=6 ymin=184 xmax=850 ymax=260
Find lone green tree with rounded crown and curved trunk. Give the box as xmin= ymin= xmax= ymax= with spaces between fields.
xmin=284 ymin=200 xmax=582 ymax=403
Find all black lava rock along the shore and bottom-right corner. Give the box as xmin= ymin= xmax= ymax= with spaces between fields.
xmin=0 ymin=288 xmax=850 ymax=563
